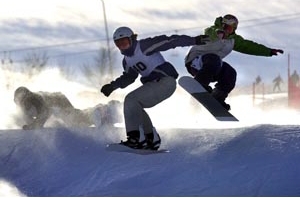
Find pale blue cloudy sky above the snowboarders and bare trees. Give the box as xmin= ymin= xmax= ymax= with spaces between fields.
xmin=0 ymin=0 xmax=300 ymax=83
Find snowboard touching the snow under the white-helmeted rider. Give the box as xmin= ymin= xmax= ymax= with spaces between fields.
xmin=106 ymin=143 xmax=170 ymax=155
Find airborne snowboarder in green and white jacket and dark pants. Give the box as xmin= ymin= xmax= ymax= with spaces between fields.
xmin=185 ymin=14 xmax=283 ymax=110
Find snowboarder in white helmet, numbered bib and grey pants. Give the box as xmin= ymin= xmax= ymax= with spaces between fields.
xmin=101 ymin=27 xmax=208 ymax=150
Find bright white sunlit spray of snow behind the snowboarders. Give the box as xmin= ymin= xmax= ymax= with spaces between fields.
xmin=0 ymin=68 xmax=299 ymax=129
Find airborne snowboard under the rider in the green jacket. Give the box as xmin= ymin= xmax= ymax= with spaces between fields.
xmin=178 ymin=76 xmax=239 ymax=121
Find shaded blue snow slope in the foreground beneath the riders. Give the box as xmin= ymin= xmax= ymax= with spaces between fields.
xmin=0 ymin=125 xmax=300 ymax=196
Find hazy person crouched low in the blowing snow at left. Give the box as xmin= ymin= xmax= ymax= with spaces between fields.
xmin=14 ymin=87 xmax=122 ymax=130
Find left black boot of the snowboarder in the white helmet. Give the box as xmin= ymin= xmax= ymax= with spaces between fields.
xmin=120 ymin=130 xmax=147 ymax=149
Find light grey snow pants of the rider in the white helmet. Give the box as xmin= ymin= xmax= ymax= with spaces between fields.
xmin=124 ymin=76 xmax=176 ymax=134
